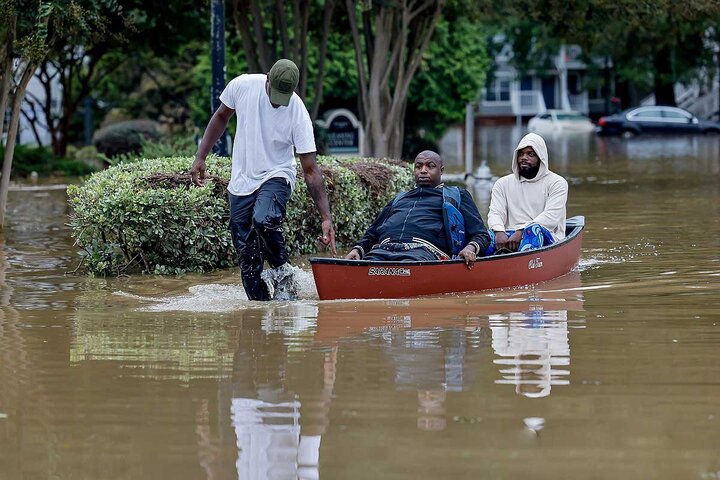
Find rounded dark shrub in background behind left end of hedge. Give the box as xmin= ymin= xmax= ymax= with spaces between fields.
xmin=93 ymin=120 xmax=160 ymax=157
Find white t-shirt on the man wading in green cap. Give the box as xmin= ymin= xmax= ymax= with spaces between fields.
xmin=220 ymin=74 xmax=316 ymax=195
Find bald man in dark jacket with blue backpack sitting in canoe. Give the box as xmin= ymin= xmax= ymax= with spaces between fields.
xmin=345 ymin=150 xmax=490 ymax=268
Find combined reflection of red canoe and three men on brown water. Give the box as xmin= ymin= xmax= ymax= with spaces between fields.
xmin=231 ymin=272 xmax=583 ymax=479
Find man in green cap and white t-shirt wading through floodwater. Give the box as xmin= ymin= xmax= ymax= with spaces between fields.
xmin=191 ymin=59 xmax=335 ymax=300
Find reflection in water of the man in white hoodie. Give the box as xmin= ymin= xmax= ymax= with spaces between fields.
xmin=490 ymin=309 xmax=570 ymax=398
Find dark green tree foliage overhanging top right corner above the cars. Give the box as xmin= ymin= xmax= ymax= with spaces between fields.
xmin=483 ymin=0 xmax=720 ymax=105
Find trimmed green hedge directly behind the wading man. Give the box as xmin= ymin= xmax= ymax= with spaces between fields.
xmin=68 ymin=156 xmax=414 ymax=275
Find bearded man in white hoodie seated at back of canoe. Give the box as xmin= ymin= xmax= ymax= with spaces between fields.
xmin=486 ymin=133 xmax=568 ymax=255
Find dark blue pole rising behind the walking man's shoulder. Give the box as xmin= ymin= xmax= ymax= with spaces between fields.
xmin=210 ymin=0 xmax=228 ymax=157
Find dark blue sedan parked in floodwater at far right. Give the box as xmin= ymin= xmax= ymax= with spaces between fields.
xmin=598 ymin=106 xmax=720 ymax=138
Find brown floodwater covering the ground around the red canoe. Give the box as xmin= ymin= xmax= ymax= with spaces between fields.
xmin=0 ymin=128 xmax=720 ymax=480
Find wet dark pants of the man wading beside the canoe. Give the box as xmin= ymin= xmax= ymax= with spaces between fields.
xmin=228 ymin=178 xmax=290 ymax=300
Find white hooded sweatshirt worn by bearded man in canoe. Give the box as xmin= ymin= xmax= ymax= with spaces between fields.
xmin=488 ymin=133 xmax=568 ymax=241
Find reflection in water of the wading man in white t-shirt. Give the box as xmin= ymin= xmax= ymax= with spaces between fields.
xmin=231 ymin=313 xmax=337 ymax=480
